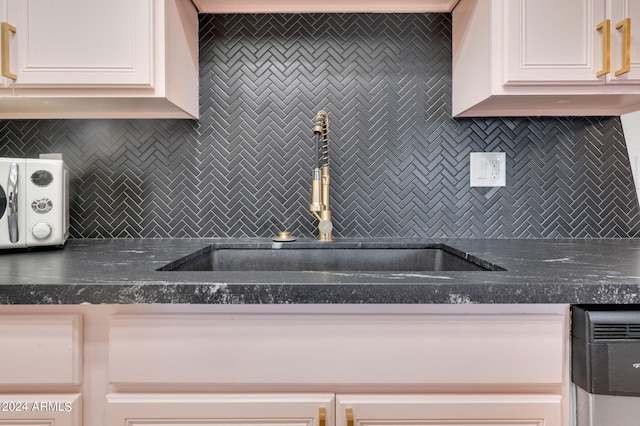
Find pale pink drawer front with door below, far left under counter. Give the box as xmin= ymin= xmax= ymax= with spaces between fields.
xmin=0 ymin=313 xmax=83 ymax=426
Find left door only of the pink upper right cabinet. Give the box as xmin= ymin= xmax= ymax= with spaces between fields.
xmin=504 ymin=0 xmax=604 ymax=85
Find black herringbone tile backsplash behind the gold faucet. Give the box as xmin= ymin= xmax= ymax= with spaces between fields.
xmin=0 ymin=14 xmax=640 ymax=238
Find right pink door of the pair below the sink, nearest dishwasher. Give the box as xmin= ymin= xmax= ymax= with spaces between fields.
xmin=336 ymin=394 xmax=562 ymax=426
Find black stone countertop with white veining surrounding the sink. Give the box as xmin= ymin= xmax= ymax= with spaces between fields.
xmin=0 ymin=239 xmax=640 ymax=304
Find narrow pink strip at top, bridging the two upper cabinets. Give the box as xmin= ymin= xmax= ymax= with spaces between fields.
xmin=193 ymin=0 xmax=459 ymax=13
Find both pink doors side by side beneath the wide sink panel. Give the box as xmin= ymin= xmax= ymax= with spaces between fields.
xmin=105 ymin=393 xmax=562 ymax=426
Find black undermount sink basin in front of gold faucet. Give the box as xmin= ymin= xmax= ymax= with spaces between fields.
xmin=158 ymin=242 xmax=505 ymax=272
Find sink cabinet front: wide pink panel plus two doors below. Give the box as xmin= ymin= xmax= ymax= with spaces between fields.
xmin=105 ymin=308 xmax=569 ymax=426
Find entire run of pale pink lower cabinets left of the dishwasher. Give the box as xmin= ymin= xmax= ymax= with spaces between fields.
xmin=0 ymin=304 xmax=570 ymax=426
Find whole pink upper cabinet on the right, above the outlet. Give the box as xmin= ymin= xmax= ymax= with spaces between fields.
xmin=453 ymin=0 xmax=640 ymax=116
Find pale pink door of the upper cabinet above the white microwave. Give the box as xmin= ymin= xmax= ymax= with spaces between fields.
xmin=5 ymin=0 xmax=154 ymax=87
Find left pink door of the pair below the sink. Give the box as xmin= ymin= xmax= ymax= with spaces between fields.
xmin=104 ymin=394 xmax=334 ymax=426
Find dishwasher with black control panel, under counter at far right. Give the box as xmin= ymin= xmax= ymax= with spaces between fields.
xmin=571 ymin=305 xmax=640 ymax=426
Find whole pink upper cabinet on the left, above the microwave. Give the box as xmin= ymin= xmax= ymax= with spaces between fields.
xmin=0 ymin=0 xmax=199 ymax=118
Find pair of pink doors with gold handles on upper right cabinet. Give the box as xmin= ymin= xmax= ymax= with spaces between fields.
xmin=505 ymin=0 xmax=640 ymax=84
